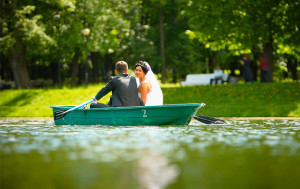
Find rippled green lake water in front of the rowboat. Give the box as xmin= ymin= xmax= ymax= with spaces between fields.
xmin=0 ymin=119 xmax=300 ymax=189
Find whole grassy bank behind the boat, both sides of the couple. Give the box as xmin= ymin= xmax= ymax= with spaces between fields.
xmin=0 ymin=82 xmax=300 ymax=119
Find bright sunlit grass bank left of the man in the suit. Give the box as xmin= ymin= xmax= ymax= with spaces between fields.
xmin=0 ymin=84 xmax=110 ymax=117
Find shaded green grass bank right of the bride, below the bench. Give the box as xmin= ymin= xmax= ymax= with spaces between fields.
xmin=164 ymin=83 xmax=300 ymax=117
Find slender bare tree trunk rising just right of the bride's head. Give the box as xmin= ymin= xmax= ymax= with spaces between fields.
xmin=159 ymin=9 xmax=166 ymax=83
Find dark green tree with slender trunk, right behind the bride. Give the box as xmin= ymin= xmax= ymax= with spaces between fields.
xmin=142 ymin=0 xmax=205 ymax=82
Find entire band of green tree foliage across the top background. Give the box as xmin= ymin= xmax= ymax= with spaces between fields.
xmin=0 ymin=0 xmax=300 ymax=88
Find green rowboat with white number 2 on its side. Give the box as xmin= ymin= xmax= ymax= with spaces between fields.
xmin=50 ymin=104 xmax=203 ymax=126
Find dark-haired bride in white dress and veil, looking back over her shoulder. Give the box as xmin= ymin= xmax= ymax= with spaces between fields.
xmin=134 ymin=61 xmax=163 ymax=106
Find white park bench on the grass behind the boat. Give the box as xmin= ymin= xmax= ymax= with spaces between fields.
xmin=180 ymin=73 xmax=229 ymax=86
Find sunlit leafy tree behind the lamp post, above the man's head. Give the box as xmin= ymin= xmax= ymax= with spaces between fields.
xmin=55 ymin=0 xmax=145 ymax=84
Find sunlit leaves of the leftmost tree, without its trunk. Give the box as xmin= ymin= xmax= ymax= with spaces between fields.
xmin=0 ymin=0 xmax=74 ymax=56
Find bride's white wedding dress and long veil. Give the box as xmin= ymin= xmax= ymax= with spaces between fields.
xmin=137 ymin=62 xmax=163 ymax=106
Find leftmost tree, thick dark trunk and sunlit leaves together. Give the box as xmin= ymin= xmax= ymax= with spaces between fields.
xmin=1 ymin=0 xmax=73 ymax=88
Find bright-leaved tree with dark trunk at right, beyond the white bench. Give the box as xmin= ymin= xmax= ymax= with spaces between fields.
xmin=186 ymin=0 xmax=300 ymax=81
